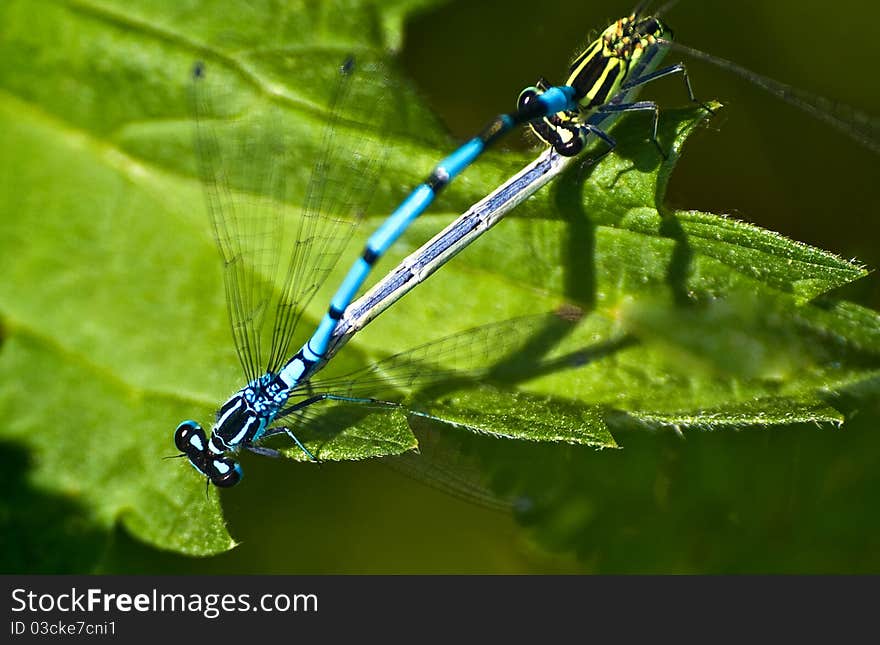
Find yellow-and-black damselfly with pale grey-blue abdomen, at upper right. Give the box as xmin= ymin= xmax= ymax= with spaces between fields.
xmin=331 ymin=0 xmax=880 ymax=342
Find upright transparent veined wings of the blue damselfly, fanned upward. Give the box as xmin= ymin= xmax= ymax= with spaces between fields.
xmin=192 ymin=59 xmax=391 ymax=380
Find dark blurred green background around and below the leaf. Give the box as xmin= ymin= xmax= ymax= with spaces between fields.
xmin=0 ymin=0 xmax=880 ymax=573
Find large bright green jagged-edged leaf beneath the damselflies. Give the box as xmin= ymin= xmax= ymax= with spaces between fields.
xmin=0 ymin=1 xmax=880 ymax=571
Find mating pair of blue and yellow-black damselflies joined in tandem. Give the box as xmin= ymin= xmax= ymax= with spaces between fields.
xmin=175 ymin=3 xmax=870 ymax=486
